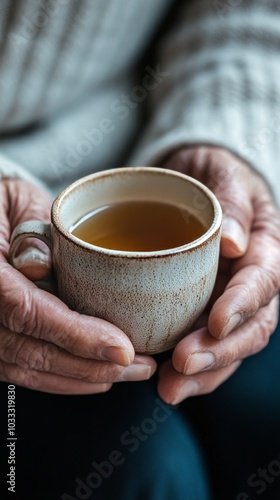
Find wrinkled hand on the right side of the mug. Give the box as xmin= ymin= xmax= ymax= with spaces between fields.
xmin=158 ymin=146 xmax=280 ymax=404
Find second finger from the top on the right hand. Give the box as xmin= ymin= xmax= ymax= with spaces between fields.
xmin=208 ymin=232 xmax=280 ymax=338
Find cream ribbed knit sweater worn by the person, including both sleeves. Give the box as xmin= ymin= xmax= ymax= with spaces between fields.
xmin=0 ymin=0 xmax=280 ymax=204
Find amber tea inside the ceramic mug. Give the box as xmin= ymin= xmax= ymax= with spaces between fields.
xmin=71 ymin=201 xmax=206 ymax=252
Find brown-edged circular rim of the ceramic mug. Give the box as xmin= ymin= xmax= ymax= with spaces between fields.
xmin=51 ymin=166 xmax=222 ymax=259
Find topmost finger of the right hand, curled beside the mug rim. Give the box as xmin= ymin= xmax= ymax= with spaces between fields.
xmin=162 ymin=146 xmax=257 ymax=258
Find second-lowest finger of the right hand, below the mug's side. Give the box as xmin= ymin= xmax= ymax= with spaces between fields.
xmin=172 ymin=298 xmax=278 ymax=375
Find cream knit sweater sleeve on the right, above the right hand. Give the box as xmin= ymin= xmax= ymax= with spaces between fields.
xmin=130 ymin=0 xmax=280 ymax=204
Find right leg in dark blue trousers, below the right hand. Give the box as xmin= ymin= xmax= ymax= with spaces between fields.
xmin=182 ymin=310 xmax=280 ymax=500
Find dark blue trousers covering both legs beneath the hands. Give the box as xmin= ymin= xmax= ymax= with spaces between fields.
xmin=0 ymin=314 xmax=280 ymax=500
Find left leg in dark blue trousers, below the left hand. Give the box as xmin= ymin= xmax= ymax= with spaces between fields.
xmin=0 ymin=380 xmax=209 ymax=500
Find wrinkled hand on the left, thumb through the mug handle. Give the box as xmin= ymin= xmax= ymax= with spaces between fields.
xmin=0 ymin=179 xmax=156 ymax=394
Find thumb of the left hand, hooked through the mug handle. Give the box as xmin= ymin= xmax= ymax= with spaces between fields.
xmin=7 ymin=181 xmax=52 ymax=281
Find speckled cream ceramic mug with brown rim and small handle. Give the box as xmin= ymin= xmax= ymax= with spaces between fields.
xmin=10 ymin=167 xmax=222 ymax=354
